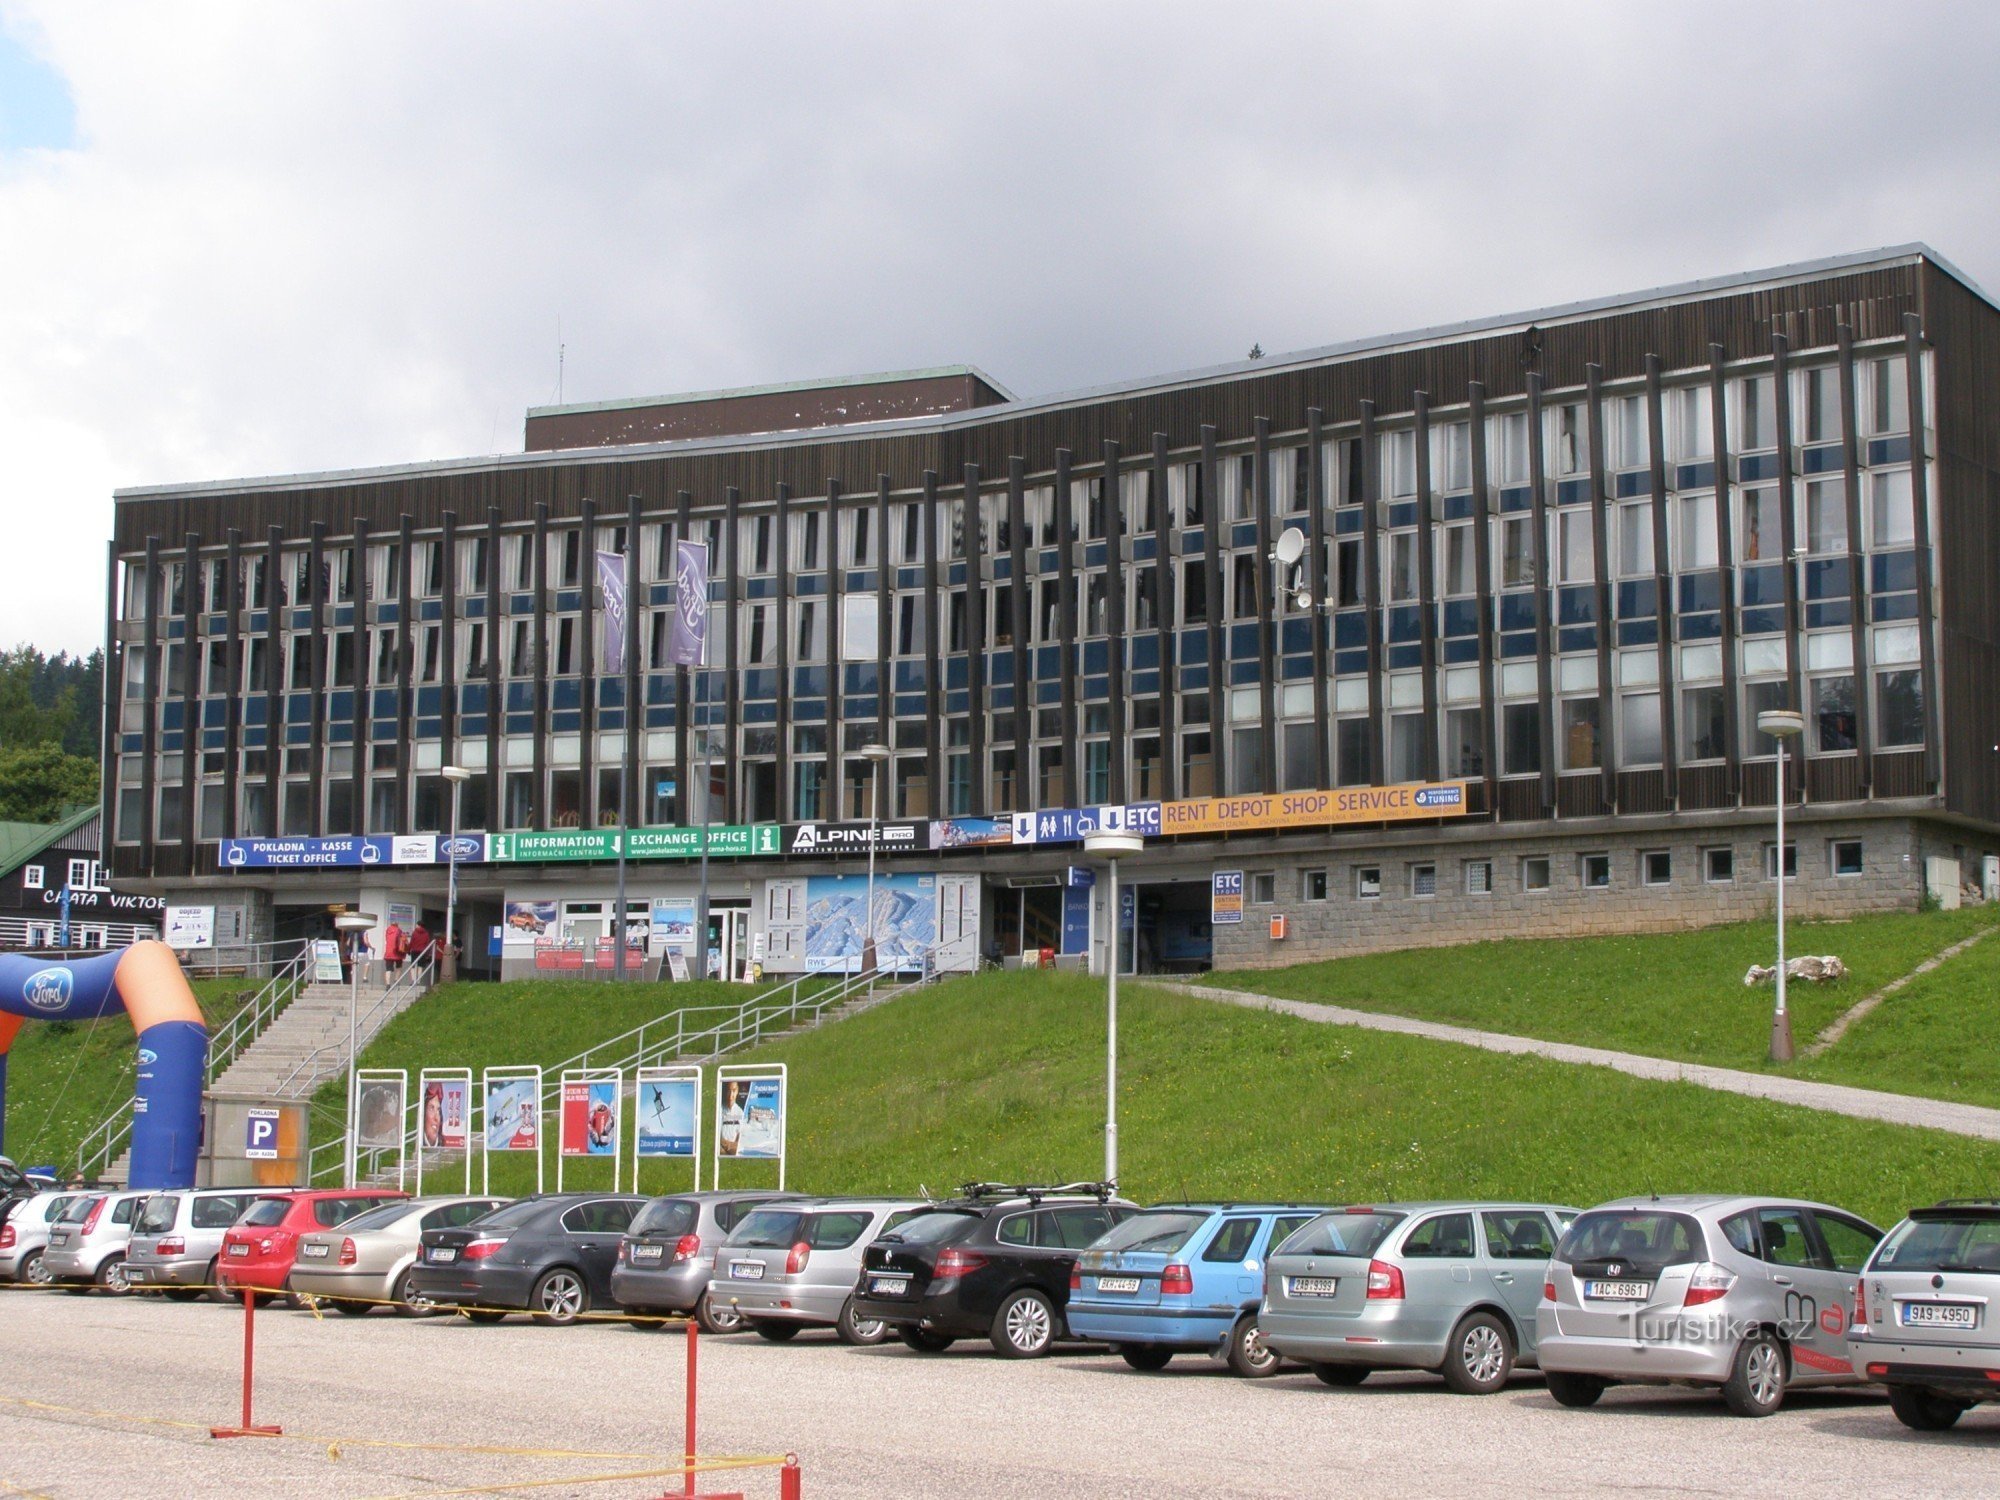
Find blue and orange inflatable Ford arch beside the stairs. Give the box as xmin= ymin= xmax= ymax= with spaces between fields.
xmin=0 ymin=942 xmax=208 ymax=1188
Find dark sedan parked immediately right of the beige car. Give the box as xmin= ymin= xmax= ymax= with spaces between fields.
xmin=410 ymin=1192 xmax=646 ymax=1326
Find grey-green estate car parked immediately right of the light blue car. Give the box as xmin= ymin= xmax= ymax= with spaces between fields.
xmin=1258 ymin=1202 xmax=1576 ymax=1396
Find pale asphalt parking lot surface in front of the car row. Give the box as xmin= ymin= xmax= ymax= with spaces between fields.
xmin=0 ymin=1292 xmax=2000 ymax=1500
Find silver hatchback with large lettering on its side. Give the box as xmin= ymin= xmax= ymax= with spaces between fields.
xmin=1536 ymin=1196 xmax=1882 ymax=1416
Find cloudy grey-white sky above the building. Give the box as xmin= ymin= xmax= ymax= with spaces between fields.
xmin=0 ymin=0 xmax=2000 ymax=650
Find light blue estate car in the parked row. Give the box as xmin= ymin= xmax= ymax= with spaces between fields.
xmin=1066 ymin=1204 xmax=1324 ymax=1376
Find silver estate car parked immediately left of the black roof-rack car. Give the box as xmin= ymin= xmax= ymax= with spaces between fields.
xmin=708 ymin=1198 xmax=924 ymax=1344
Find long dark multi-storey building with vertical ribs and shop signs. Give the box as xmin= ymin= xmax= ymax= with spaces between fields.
xmin=104 ymin=246 xmax=2000 ymax=972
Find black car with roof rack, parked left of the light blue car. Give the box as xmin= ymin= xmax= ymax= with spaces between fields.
xmin=852 ymin=1182 xmax=1138 ymax=1360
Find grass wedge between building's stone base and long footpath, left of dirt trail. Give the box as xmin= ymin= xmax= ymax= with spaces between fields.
xmin=1208 ymin=908 xmax=2000 ymax=1088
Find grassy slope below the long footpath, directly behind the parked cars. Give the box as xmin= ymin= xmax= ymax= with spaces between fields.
xmin=464 ymin=974 xmax=2000 ymax=1220
